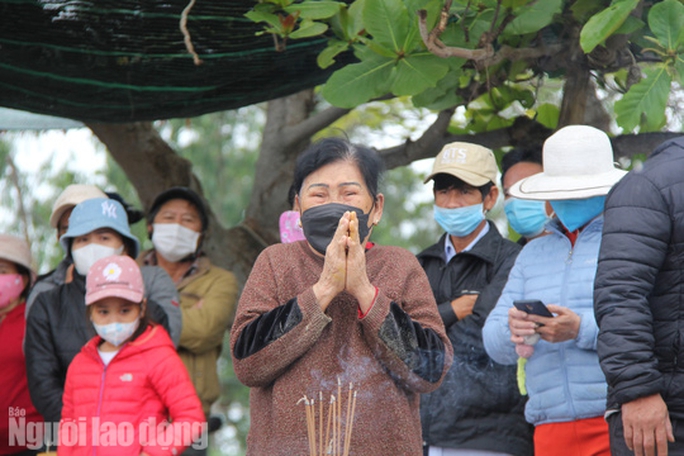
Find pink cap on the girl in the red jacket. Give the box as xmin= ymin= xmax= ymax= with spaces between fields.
xmin=85 ymin=255 xmax=145 ymax=306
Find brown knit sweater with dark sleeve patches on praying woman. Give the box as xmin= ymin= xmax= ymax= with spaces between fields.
xmin=231 ymin=241 xmax=452 ymax=456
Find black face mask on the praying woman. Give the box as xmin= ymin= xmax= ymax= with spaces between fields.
xmin=302 ymin=203 xmax=370 ymax=255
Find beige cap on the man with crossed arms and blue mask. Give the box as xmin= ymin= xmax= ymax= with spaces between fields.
xmin=424 ymin=142 xmax=498 ymax=187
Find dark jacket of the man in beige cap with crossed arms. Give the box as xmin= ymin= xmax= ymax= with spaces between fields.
xmin=418 ymin=222 xmax=533 ymax=456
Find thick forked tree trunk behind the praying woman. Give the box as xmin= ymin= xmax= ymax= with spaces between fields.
xmin=88 ymin=90 xmax=349 ymax=284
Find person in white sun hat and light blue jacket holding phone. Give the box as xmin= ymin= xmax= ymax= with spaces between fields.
xmin=482 ymin=125 xmax=625 ymax=456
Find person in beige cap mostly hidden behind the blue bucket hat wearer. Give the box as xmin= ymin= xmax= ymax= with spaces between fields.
xmin=26 ymin=184 xmax=107 ymax=316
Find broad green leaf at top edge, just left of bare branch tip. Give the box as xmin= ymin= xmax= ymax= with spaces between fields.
xmin=363 ymin=0 xmax=409 ymax=54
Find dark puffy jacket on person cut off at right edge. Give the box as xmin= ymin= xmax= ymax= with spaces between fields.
xmin=594 ymin=137 xmax=684 ymax=419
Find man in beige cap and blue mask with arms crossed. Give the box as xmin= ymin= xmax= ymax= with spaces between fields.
xmin=418 ymin=142 xmax=532 ymax=456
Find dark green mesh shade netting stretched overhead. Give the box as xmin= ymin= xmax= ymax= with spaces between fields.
xmin=0 ymin=0 xmax=342 ymax=122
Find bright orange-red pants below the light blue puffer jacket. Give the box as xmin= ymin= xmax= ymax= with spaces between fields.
xmin=534 ymin=416 xmax=610 ymax=456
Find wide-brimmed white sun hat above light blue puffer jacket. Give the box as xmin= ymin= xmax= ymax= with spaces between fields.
xmin=509 ymin=125 xmax=627 ymax=201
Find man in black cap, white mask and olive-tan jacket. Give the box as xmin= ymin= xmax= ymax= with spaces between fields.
xmin=138 ymin=187 xmax=238 ymax=455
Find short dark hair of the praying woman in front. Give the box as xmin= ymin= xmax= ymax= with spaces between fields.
xmin=288 ymin=138 xmax=385 ymax=201
